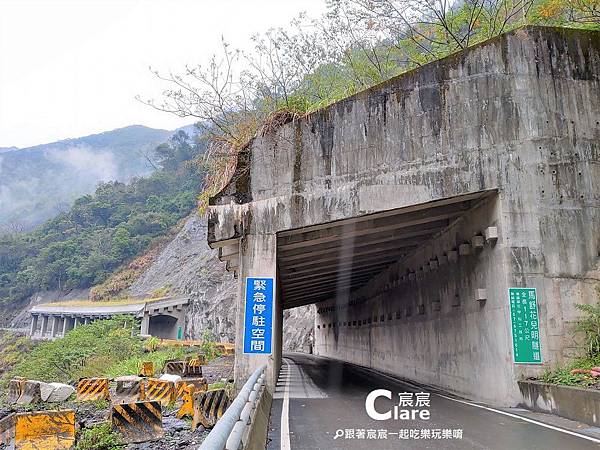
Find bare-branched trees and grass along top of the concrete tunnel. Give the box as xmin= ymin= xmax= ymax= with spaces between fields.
xmin=146 ymin=0 xmax=600 ymax=211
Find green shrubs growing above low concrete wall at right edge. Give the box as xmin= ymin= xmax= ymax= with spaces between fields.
xmin=540 ymin=303 xmax=600 ymax=386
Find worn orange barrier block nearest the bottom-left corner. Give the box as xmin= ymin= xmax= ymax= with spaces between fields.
xmin=14 ymin=410 xmax=75 ymax=450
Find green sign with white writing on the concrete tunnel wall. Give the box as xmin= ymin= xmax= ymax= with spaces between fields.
xmin=508 ymin=288 xmax=542 ymax=364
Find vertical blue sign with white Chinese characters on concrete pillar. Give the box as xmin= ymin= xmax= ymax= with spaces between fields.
xmin=244 ymin=277 xmax=275 ymax=355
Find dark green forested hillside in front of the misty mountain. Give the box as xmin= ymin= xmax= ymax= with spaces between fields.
xmin=0 ymin=131 xmax=205 ymax=303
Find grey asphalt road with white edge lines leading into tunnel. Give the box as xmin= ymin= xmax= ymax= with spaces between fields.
xmin=267 ymin=354 xmax=600 ymax=450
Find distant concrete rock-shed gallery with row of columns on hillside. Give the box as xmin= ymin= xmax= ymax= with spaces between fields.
xmin=29 ymin=298 xmax=189 ymax=339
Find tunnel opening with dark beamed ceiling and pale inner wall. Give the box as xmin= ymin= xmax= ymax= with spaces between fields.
xmin=277 ymin=191 xmax=506 ymax=400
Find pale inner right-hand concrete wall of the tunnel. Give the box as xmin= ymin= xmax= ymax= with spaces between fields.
xmin=315 ymin=197 xmax=524 ymax=402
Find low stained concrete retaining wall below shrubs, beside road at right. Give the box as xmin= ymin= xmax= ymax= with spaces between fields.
xmin=519 ymin=381 xmax=600 ymax=426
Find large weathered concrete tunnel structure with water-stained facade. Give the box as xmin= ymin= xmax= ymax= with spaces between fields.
xmin=208 ymin=27 xmax=600 ymax=406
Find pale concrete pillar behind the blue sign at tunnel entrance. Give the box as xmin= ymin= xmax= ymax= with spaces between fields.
xmin=234 ymin=234 xmax=283 ymax=393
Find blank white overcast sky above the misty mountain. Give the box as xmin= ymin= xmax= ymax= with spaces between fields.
xmin=0 ymin=0 xmax=325 ymax=147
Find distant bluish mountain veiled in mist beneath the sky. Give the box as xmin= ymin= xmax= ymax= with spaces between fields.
xmin=0 ymin=125 xmax=194 ymax=232
